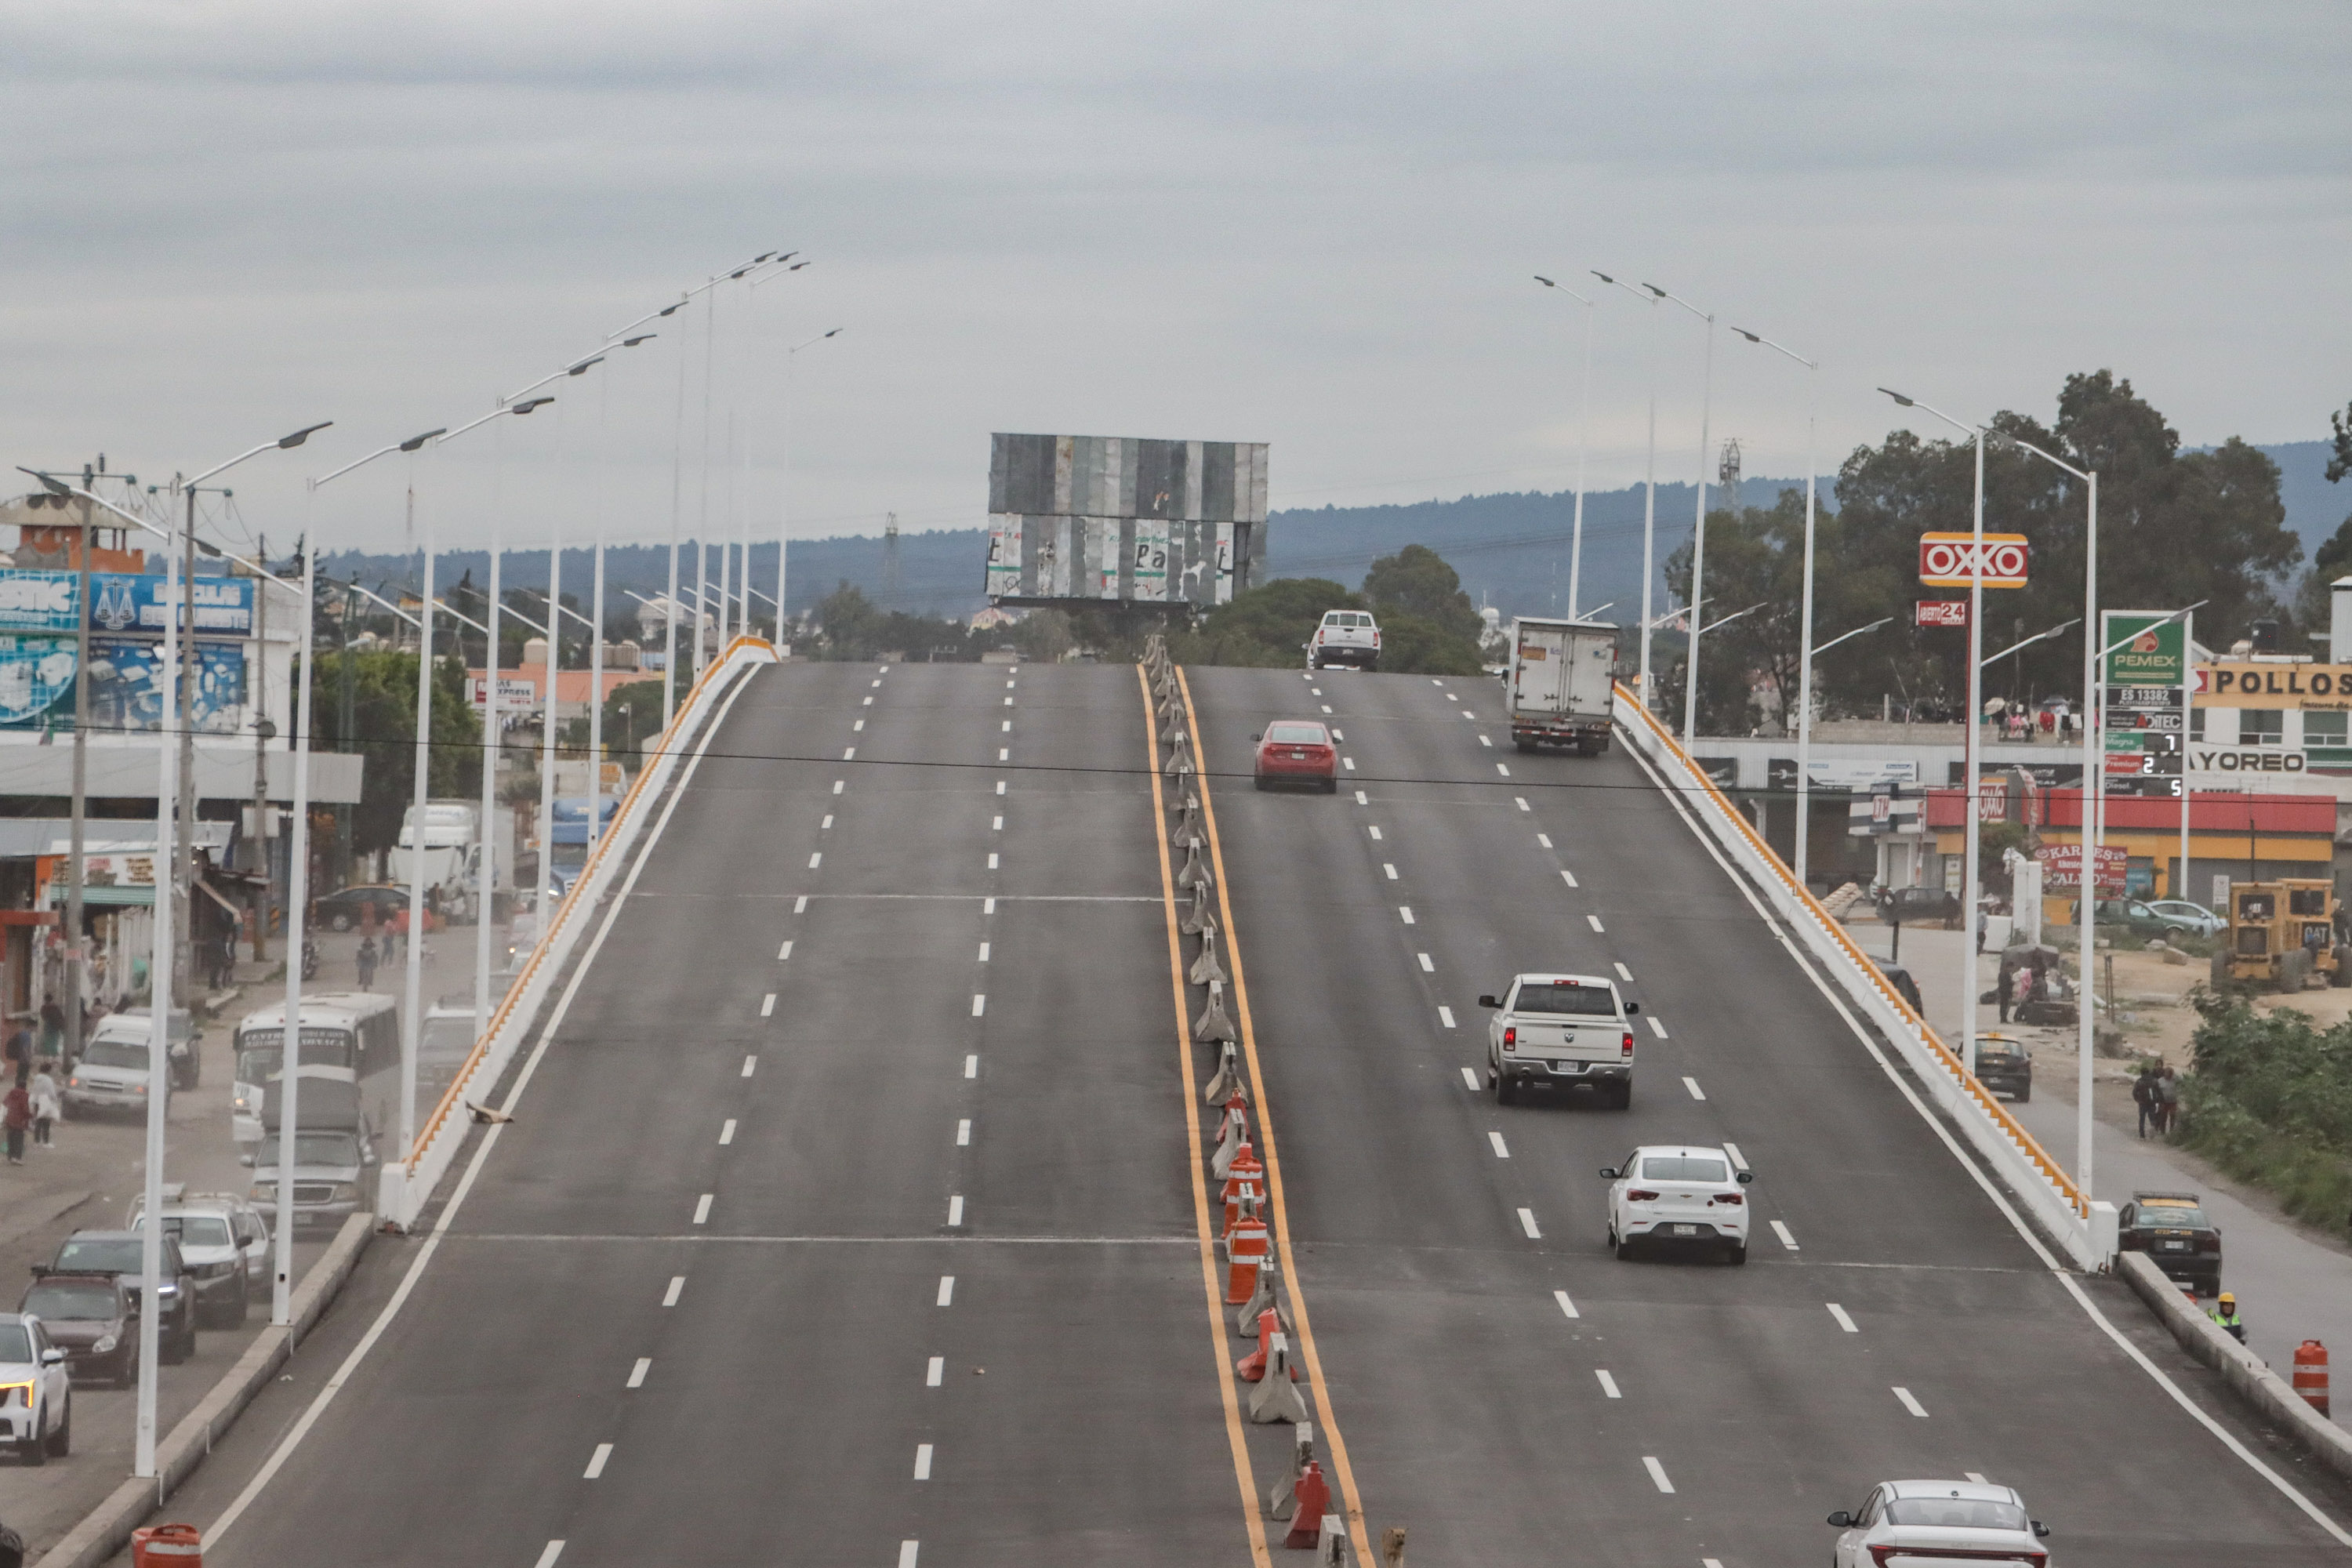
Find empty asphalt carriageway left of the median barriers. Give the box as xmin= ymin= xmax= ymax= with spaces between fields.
xmin=174 ymin=666 xmax=1247 ymax=1568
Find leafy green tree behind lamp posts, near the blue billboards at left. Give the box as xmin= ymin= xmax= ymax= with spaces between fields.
xmin=310 ymin=649 xmax=482 ymax=853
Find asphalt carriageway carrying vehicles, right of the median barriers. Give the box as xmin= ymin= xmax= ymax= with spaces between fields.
xmin=1190 ymin=670 xmax=2347 ymax=1568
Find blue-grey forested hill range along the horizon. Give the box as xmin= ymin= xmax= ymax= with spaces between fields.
xmin=320 ymin=442 xmax=2352 ymax=619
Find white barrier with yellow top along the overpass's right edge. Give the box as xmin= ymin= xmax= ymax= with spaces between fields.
xmin=1616 ymin=687 xmax=2110 ymax=1269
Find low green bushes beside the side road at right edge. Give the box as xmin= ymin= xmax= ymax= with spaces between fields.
xmin=2173 ymin=987 xmax=2352 ymax=1229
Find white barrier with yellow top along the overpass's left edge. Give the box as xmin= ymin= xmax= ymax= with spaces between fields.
xmin=376 ymin=637 xmax=776 ymax=1229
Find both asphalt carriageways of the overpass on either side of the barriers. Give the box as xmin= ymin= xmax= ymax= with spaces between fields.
xmin=137 ymin=663 xmax=2352 ymax=1568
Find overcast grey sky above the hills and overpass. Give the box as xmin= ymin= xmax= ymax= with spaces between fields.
xmin=0 ymin=0 xmax=2352 ymax=548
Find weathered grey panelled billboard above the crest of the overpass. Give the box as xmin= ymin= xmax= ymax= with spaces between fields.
xmin=988 ymin=433 xmax=1265 ymax=609
